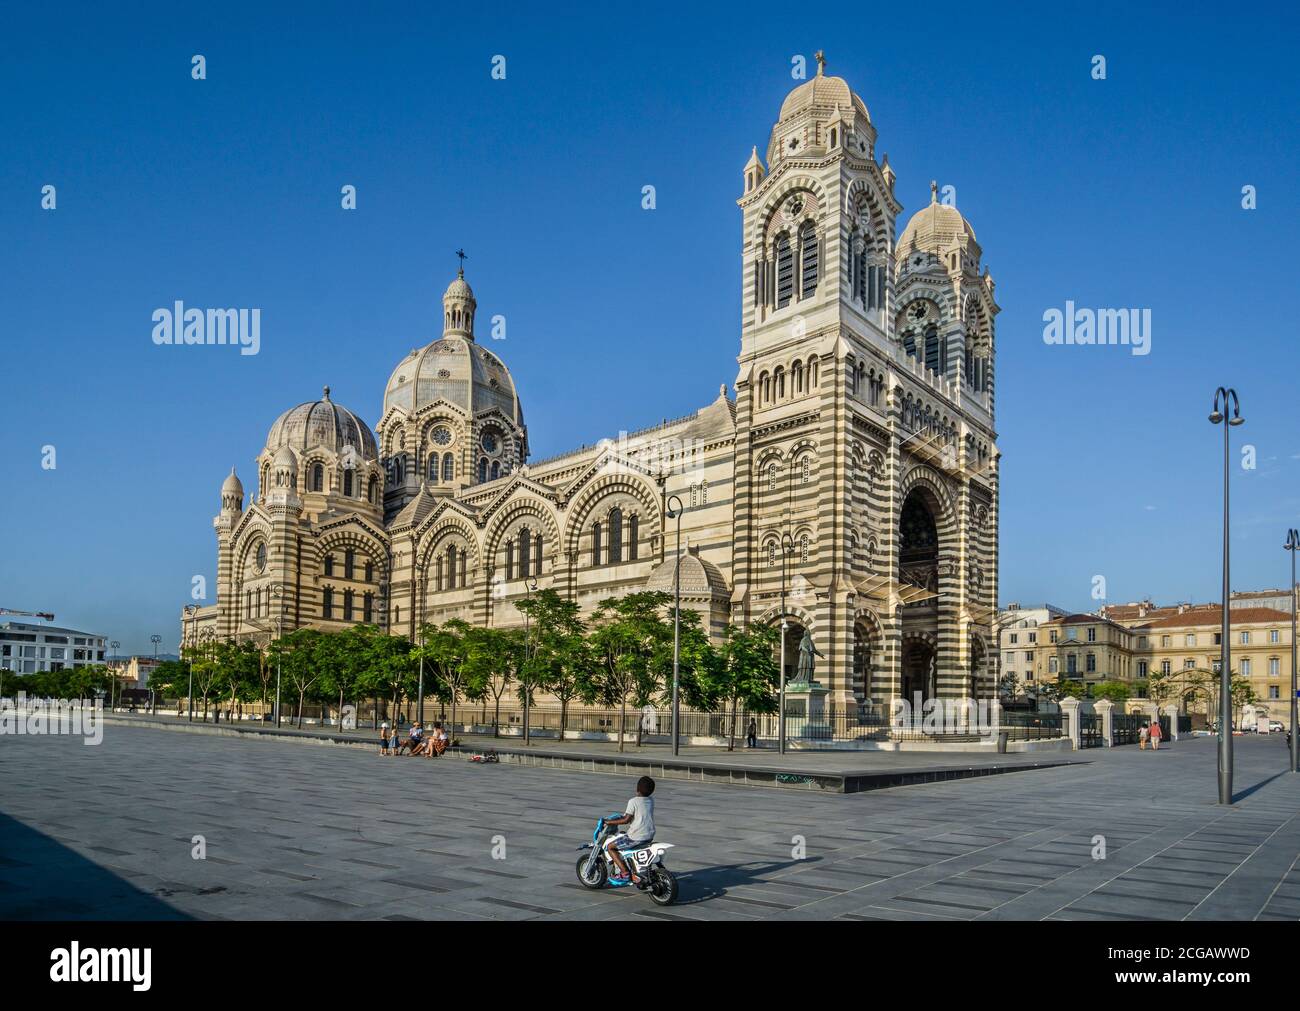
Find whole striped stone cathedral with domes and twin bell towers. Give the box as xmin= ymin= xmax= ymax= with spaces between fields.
xmin=182 ymin=55 xmax=998 ymax=712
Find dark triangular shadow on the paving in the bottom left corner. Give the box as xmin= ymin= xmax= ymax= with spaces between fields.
xmin=0 ymin=813 xmax=192 ymax=920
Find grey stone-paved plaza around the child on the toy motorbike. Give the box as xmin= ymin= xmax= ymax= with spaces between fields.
xmin=0 ymin=726 xmax=1300 ymax=920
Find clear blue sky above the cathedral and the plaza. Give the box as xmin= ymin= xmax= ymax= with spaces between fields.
xmin=0 ymin=3 xmax=1300 ymax=652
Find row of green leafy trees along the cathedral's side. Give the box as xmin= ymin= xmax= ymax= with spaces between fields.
xmin=151 ymin=589 xmax=779 ymax=750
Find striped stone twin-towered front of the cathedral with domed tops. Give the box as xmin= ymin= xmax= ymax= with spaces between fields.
xmin=732 ymin=53 xmax=997 ymax=711
